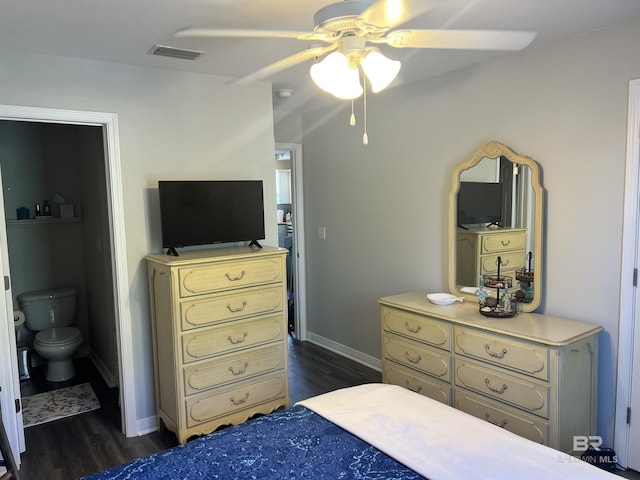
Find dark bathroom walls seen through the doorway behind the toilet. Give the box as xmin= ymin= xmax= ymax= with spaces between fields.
xmin=0 ymin=120 xmax=118 ymax=397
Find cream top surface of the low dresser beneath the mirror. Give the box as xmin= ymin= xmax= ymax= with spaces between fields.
xmin=378 ymin=292 xmax=603 ymax=346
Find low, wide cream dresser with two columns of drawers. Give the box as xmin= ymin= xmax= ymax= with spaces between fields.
xmin=379 ymin=292 xmax=602 ymax=452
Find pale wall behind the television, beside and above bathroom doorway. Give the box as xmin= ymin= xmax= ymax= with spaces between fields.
xmin=0 ymin=52 xmax=277 ymax=420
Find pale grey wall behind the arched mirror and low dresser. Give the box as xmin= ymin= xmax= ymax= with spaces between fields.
xmin=303 ymin=20 xmax=640 ymax=445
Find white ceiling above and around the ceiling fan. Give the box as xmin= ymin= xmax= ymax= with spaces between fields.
xmin=0 ymin=0 xmax=640 ymax=113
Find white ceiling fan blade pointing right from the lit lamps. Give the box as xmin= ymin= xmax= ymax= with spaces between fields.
xmin=378 ymin=30 xmax=536 ymax=50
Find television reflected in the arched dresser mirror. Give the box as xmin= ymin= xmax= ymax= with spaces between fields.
xmin=458 ymin=182 xmax=502 ymax=226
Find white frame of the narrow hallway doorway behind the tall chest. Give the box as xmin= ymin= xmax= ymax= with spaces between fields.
xmin=275 ymin=142 xmax=307 ymax=341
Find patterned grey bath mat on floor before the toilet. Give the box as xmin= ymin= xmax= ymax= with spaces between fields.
xmin=22 ymin=383 xmax=100 ymax=428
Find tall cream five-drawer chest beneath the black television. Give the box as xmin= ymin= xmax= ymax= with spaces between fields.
xmin=147 ymin=247 xmax=289 ymax=443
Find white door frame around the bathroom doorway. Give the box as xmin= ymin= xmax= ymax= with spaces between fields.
xmin=0 ymin=105 xmax=138 ymax=437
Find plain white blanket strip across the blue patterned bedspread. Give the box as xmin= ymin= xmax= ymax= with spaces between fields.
xmin=297 ymin=384 xmax=619 ymax=480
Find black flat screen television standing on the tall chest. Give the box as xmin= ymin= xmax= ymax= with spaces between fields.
xmin=158 ymin=180 xmax=265 ymax=255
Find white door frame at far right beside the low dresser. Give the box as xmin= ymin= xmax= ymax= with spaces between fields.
xmin=614 ymin=79 xmax=640 ymax=468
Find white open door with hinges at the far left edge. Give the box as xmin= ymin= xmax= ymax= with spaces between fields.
xmin=0 ymin=161 xmax=25 ymax=466
